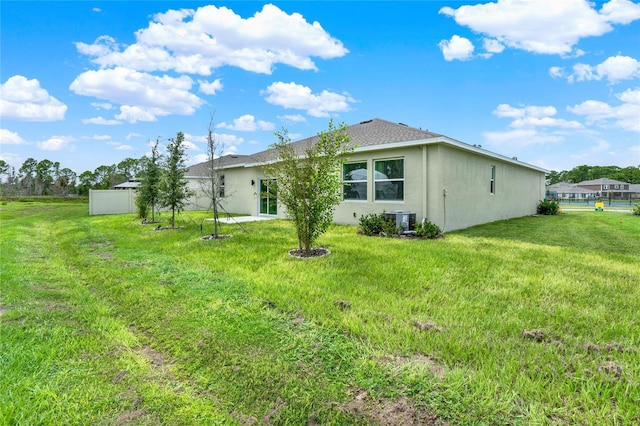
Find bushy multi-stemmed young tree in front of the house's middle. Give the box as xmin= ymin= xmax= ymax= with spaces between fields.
xmin=265 ymin=120 xmax=352 ymax=256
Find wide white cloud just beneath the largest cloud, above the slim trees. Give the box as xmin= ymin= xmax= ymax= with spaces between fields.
xmin=69 ymin=67 xmax=204 ymax=123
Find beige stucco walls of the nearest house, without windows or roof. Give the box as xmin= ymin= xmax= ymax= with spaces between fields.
xmin=184 ymin=144 xmax=545 ymax=231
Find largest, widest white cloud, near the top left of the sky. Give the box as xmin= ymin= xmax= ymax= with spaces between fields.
xmin=76 ymin=4 xmax=348 ymax=75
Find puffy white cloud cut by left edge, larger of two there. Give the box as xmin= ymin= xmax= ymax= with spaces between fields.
xmin=0 ymin=75 xmax=67 ymax=121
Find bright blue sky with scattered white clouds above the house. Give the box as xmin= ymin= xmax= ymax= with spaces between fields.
xmin=0 ymin=0 xmax=640 ymax=173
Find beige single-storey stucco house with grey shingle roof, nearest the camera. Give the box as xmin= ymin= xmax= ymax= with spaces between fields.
xmin=185 ymin=119 xmax=547 ymax=231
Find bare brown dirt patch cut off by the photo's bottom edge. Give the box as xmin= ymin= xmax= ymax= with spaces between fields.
xmin=337 ymin=389 xmax=448 ymax=426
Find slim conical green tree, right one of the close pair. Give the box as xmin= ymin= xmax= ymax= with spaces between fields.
xmin=160 ymin=132 xmax=191 ymax=228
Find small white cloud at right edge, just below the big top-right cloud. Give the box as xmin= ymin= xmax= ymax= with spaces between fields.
xmin=566 ymin=55 xmax=640 ymax=83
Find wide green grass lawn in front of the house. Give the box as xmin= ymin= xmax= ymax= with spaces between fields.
xmin=0 ymin=202 xmax=640 ymax=425
